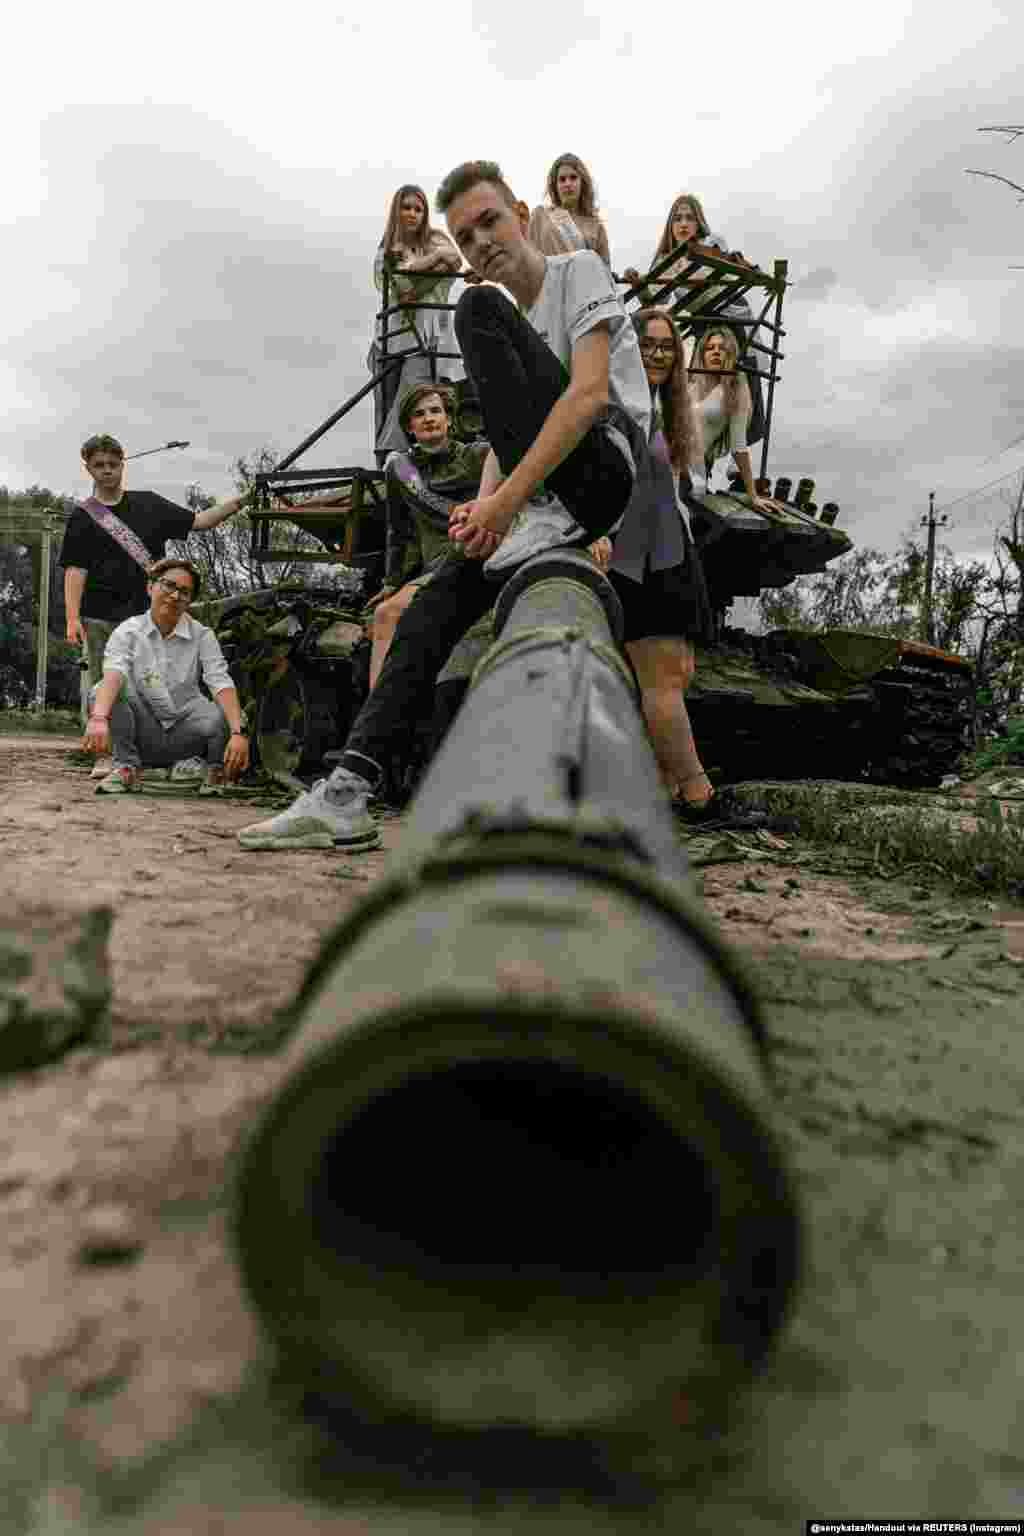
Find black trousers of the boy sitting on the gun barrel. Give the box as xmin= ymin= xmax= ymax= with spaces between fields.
xmin=341 ymin=287 xmax=633 ymax=782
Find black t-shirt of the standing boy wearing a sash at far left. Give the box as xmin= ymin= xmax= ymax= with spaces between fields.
xmin=60 ymin=490 xmax=193 ymax=624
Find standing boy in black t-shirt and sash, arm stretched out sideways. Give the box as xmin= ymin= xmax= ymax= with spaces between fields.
xmin=60 ymin=432 xmax=246 ymax=758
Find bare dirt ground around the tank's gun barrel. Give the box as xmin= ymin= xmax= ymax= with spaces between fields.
xmin=0 ymin=736 xmax=1024 ymax=1536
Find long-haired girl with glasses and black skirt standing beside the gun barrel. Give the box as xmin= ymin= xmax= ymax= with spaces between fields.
xmin=608 ymin=309 xmax=714 ymax=820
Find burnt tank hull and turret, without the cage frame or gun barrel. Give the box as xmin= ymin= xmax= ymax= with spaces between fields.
xmin=197 ymin=492 xmax=972 ymax=800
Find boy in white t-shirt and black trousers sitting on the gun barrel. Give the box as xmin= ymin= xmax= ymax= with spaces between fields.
xmin=238 ymin=160 xmax=651 ymax=848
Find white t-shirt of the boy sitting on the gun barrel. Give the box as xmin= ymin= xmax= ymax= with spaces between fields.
xmin=527 ymin=250 xmax=651 ymax=444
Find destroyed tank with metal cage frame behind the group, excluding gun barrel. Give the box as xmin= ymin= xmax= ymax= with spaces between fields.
xmin=197 ymin=246 xmax=972 ymax=799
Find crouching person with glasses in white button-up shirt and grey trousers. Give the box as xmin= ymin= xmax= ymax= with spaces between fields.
xmin=81 ymin=556 xmax=249 ymax=794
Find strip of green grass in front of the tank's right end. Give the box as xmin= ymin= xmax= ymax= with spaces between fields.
xmin=749 ymin=785 xmax=1024 ymax=902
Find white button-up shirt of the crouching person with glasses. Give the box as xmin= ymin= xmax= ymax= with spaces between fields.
xmin=103 ymin=613 xmax=235 ymax=731
